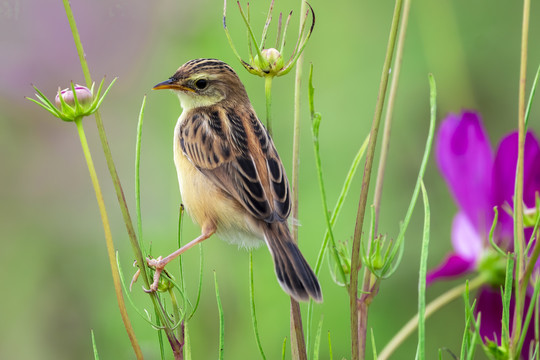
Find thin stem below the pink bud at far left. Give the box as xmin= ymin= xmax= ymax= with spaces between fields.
xmin=75 ymin=118 xmax=143 ymax=359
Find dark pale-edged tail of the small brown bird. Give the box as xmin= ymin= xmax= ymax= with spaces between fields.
xmin=264 ymin=221 xmax=322 ymax=302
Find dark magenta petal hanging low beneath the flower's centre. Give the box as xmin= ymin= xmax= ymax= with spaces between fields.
xmin=475 ymin=287 xmax=502 ymax=345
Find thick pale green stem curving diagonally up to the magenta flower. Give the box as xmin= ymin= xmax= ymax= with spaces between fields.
xmin=378 ymin=275 xmax=486 ymax=360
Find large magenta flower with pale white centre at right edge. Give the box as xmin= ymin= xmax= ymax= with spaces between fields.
xmin=427 ymin=111 xmax=540 ymax=354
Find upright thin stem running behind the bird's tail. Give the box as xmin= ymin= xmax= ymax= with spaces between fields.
xmin=290 ymin=0 xmax=307 ymax=360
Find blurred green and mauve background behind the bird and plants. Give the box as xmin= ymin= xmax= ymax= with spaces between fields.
xmin=0 ymin=0 xmax=540 ymax=359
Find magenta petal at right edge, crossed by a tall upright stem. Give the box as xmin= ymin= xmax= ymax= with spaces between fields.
xmin=493 ymin=133 xmax=540 ymax=240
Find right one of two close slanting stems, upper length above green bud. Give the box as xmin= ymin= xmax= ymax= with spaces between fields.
xmin=373 ymin=0 xmax=411 ymax=233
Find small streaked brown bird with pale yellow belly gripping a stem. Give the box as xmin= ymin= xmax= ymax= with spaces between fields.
xmin=147 ymin=59 xmax=322 ymax=302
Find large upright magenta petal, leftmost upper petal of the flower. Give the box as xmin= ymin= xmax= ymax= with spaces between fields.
xmin=436 ymin=112 xmax=493 ymax=232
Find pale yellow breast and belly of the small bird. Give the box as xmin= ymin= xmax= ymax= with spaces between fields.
xmin=174 ymin=117 xmax=264 ymax=248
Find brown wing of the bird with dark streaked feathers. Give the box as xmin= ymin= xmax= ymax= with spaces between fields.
xmin=178 ymin=108 xmax=291 ymax=222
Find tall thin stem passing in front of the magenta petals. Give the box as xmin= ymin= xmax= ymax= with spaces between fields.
xmin=510 ymin=0 xmax=531 ymax=356
